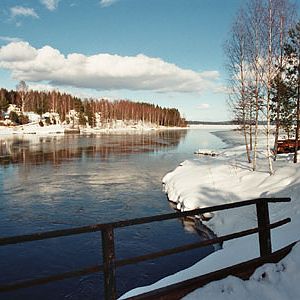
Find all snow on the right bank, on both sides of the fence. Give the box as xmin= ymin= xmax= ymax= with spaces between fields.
xmin=122 ymin=130 xmax=300 ymax=300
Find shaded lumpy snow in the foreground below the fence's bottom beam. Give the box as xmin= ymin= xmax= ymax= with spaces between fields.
xmin=183 ymin=243 xmax=300 ymax=300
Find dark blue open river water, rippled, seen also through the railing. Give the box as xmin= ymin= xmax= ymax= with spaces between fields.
xmin=0 ymin=130 xmax=224 ymax=300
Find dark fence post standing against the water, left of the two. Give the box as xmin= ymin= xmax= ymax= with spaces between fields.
xmin=102 ymin=226 xmax=116 ymax=300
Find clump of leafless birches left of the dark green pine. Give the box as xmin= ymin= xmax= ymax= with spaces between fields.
xmin=226 ymin=0 xmax=294 ymax=174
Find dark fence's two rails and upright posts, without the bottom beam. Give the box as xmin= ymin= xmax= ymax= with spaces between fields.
xmin=0 ymin=198 xmax=291 ymax=300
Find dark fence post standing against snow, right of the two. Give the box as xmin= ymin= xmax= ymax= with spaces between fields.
xmin=256 ymin=199 xmax=272 ymax=257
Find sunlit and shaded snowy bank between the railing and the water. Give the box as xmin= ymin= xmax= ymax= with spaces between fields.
xmin=121 ymin=127 xmax=300 ymax=299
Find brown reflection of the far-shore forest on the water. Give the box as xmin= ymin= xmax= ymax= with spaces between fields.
xmin=0 ymin=130 xmax=187 ymax=166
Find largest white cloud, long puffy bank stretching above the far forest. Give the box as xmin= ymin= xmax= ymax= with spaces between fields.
xmin=0 ymin=42 xmax=219 ymax=93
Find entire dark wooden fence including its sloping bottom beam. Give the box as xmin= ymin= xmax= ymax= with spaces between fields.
xmin=0 ymin=198 xmax=293 ymax=300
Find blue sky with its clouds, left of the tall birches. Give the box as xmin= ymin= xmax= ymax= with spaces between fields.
xmin=0 ymin=0 xmax=296 ymax=121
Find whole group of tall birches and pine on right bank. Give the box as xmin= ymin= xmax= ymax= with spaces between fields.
xmin=224 ymin=0 xmax=300 ymax=174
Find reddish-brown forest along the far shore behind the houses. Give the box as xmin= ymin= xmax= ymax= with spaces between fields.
xmin=0 ymin=88 xmax=186 ymax=127
